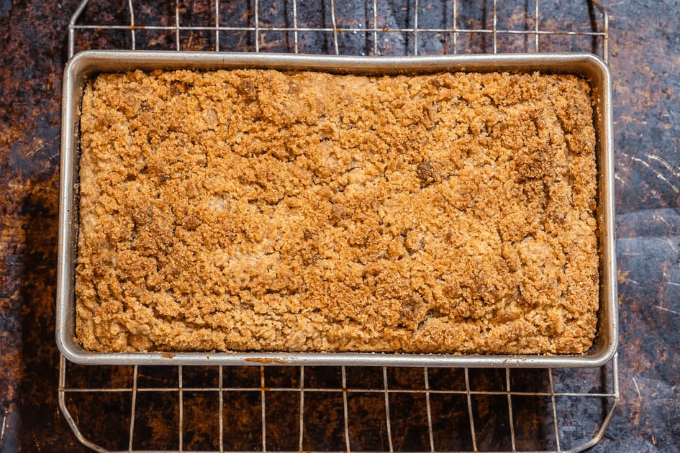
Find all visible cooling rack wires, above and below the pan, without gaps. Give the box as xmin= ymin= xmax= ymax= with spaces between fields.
xmin=61 ymin=0 xmax=619 ymax=453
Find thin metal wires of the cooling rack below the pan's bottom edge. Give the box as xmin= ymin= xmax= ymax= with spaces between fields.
xmin=59 ymin=357 xmax=619 ymax=453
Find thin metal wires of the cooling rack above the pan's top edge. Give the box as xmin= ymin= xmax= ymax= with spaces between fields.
xmin=68 ymin=0 xmax=609 ymax=62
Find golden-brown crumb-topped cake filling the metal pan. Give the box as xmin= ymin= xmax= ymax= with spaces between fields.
xmin=76 ymin=70 xmax=599 ymax=354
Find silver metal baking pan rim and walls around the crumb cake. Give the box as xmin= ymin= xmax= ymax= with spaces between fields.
xmin=56 ymin=51 xmax=618 ymax=368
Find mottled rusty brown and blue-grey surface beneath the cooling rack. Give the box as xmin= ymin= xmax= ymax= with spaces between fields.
xmin=0 ymin=0 xmax=680 ymax=452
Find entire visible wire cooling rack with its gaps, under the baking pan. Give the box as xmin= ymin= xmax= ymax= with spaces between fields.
xmin=59 ymin=0 xmax=619 ymax=453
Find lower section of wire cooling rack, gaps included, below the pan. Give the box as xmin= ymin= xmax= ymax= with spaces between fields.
xmin=59 ymin=357 xmax=619 ymax=453
